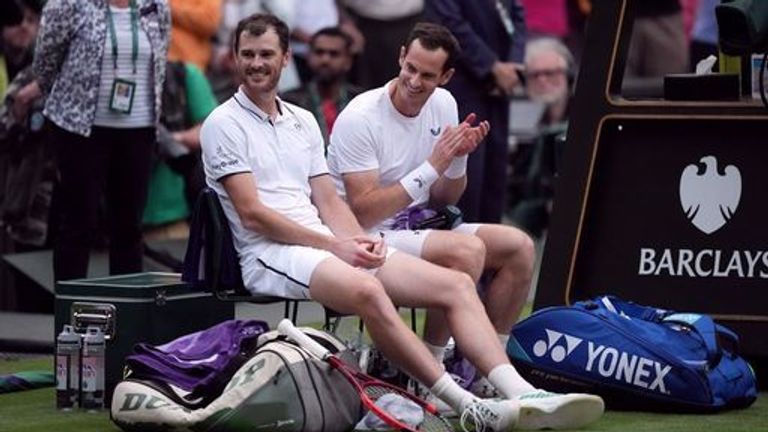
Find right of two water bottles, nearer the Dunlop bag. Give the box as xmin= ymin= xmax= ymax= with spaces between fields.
xmin=80 ymin=326 xmax=106 ymax=410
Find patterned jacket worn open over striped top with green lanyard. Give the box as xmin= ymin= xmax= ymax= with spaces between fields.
xmin=34 ymin=0 xmax=171 ymax=136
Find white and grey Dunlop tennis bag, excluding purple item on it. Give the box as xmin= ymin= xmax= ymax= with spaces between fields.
xmin=111 ymin=328 xmax=362 ymax=432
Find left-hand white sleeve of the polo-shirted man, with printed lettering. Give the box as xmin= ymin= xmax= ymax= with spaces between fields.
xmin=200 ymin=113 xmax=251 ymax=180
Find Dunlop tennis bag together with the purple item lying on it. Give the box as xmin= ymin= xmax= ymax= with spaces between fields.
xmin=110 ymin=321 xmax=362 ymax=432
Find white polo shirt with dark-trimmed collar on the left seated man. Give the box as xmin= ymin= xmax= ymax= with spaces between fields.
xmin=200 ymin=89 xmax=330 ymax=280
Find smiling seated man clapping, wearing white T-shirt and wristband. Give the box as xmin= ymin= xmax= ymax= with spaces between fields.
xmin=328 ymin=23 xmax=534 ymax=396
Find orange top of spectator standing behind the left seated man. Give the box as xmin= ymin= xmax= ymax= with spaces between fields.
xmin=168 ymin=0 xmax=221 ymax=71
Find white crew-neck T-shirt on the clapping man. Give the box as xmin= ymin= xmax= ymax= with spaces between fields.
xmin=328 ymin=81 xmax=459 ymax=232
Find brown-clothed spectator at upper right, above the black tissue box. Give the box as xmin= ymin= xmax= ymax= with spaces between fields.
xmin=625 ymin=0 xmax=688 ymax=78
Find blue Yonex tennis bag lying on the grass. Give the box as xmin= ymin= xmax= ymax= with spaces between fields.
xmin=507 ymin=297 xmax=757 ymax=412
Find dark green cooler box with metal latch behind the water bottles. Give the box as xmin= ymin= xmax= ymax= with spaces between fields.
xmin=54 ymin=273 xmax=235 ymax=406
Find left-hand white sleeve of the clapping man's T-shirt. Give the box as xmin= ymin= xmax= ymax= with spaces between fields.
xmin=328 ymin=106 xmax=379 ymax=174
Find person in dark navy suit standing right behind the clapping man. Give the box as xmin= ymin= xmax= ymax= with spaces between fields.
xmin=426 ymin=0 xmax=526 ymax=223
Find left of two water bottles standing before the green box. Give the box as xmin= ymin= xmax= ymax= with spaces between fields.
xmin=56 ymin=325 xmax=80 ymax=411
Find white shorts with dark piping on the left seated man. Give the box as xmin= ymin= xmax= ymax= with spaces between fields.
xmin=245 ymin=238 xmax=396 ymax=299
